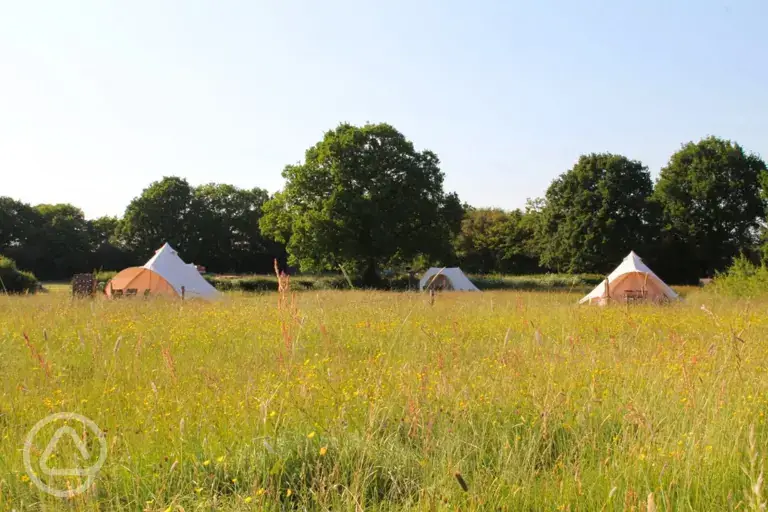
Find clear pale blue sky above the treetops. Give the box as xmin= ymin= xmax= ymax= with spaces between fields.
xmin=0 ymin=0 xmax=768 ymax=217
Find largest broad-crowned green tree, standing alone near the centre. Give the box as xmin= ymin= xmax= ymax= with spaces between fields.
xmin=261 ymin=124 xmax=457 ymax=284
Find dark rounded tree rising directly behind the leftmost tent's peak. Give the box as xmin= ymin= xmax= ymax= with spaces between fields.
xmin=119 ymin=177 xmax=200 ymax=259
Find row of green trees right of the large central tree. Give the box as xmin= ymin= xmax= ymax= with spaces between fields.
xmin=458 ymin=137 xmax=768 ymax=283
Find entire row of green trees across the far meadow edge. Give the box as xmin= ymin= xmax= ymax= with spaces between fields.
xmin=0 ymin=124 xmax=768 ymax=285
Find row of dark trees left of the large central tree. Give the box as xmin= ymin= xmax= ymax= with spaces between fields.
xmin=0 ymin=182 xmax=285 ymax=279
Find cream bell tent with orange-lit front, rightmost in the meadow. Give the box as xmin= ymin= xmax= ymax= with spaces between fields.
xmin=579 ymin=251 xmax=677 ymax=305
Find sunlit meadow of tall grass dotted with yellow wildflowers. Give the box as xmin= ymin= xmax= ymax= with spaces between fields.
xmin=0 ymin=291 xmax=768 ymax=511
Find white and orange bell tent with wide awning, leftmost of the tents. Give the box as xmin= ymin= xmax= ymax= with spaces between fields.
xmin=106 ymin=244 xmax=219 ymax=299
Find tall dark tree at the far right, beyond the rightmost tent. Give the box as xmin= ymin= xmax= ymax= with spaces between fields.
xmin=654 ymin=137 xmax=768 ymax=281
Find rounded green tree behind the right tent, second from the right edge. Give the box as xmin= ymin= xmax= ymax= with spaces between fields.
xmin=535 ymin=153 xmax=657 ymax=273
